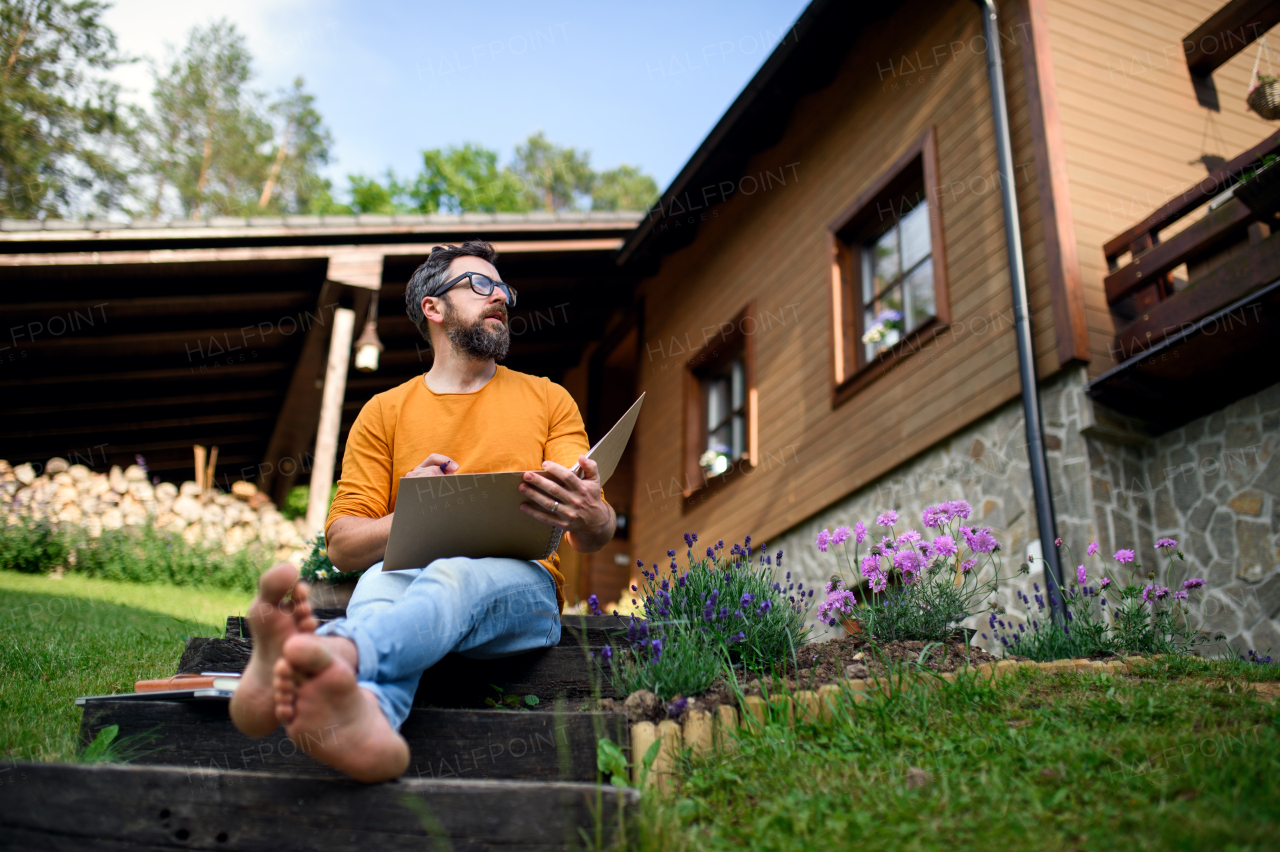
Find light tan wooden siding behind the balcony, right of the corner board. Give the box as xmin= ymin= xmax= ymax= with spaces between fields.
xmin=1043 ymin=0 xmax=1275 ymax=376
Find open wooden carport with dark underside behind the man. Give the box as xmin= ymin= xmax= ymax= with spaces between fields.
xmin=0 ymin=214 xmax=640 ymax=503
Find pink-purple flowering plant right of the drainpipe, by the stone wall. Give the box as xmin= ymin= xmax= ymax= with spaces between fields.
xmin=983 ymin=539 xmax=1212 ymax=660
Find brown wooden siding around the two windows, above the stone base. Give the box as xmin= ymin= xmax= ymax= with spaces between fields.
xmin=632 ymin=0 xmax=1044 ymax=562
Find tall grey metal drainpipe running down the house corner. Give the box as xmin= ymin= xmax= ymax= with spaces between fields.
xmin=977 ymin=0 xmax=1064 ymax=623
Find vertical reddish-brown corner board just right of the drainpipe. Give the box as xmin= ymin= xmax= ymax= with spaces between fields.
xmin=1018 ymin=0 xmax=1091 ymax=366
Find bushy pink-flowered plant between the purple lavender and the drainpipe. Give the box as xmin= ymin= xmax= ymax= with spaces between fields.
xmin=817 ymin=500 xmax=1000 ymax=641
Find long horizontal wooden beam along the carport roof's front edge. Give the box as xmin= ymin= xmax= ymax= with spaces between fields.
xmin=0 ymin=237 xmax=622 ymax=267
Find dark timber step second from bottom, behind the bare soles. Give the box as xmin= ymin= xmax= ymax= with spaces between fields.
xmin=79 ymin=700 xmax=628 ymax=783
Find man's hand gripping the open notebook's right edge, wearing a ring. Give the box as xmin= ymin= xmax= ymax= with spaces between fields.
xmin=520 ymin=455 xmax=617 ymax=553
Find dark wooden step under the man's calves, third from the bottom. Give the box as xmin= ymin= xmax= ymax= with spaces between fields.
xmin=178 ymin=637 xmax=618 ymax=710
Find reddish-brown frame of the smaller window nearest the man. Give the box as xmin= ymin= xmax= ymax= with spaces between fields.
xmin=681 ymin=302 xmax=759 ymax=512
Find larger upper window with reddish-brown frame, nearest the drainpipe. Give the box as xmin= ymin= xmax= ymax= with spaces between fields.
xmin=829 ymin=128 xmax=950 ymax=404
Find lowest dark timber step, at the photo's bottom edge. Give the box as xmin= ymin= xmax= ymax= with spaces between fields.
xmin=0 ymin=762 xmax=639 ymax=852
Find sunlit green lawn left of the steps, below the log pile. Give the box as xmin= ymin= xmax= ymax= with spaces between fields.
xmin=0 ymin=571 xmax=252 ymax=761
